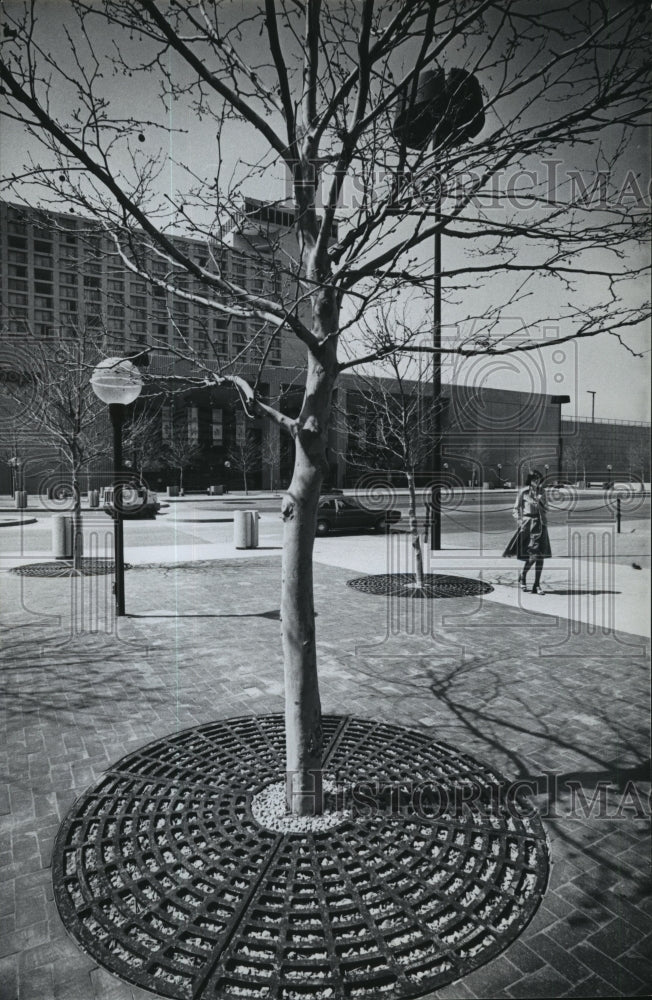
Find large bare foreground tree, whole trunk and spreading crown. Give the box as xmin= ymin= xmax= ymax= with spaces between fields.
xmin=0 ymin=0 xmax=650 ymax=812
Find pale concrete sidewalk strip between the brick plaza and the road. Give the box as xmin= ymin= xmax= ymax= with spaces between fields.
xmin=0 ymin=511 xmax=650 ymax=636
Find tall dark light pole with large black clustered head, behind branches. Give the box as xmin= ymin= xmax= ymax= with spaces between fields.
xmin=393 ymin=68 xmax=484 ymax=551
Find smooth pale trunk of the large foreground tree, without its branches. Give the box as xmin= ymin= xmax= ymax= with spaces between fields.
xmin=281 ymin=341 xmax=336 ymax=816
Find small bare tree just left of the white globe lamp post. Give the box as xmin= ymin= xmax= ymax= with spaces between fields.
xmin=0 ymin=326 xmax=107 ymax=569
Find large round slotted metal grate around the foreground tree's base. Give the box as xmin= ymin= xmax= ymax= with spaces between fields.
xmin=53 ymin=716 xmax=548 ymax=1000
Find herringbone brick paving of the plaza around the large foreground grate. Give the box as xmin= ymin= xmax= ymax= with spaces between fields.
xmin=0 ymin=557 xmax=652 ymax=1000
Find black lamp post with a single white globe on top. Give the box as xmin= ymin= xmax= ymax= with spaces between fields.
xmin=91 ymin=358 xmax=143 ymax=617
